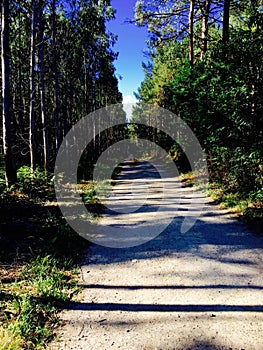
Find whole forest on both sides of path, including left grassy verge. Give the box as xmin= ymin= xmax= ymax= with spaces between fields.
xmin=0 ymin=0 xmax=263 ymax=349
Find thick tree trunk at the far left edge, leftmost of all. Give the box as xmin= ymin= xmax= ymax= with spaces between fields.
xmin=1 ymin=0 xmax=17 ymax=186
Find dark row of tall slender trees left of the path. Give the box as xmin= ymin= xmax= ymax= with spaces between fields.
xmin=0 ymin=0 xmax=122 ymax=185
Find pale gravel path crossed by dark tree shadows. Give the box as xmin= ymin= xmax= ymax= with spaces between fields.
xmin=50 ymin=162 xmax=263 ymax=350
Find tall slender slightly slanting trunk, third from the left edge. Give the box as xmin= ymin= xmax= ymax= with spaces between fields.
xmin=38 ymin=0 xmax=49 ymax=170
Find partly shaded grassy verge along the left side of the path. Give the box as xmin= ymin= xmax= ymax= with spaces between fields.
xmin=0 ymin=167 xmax=95 ymax=350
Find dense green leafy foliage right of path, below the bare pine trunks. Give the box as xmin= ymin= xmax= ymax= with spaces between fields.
xmin=133 ymin=0 xmax=263 ymax=209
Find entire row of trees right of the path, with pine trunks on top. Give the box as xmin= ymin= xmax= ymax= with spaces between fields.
xmin=133 ymin=0 xmax=263 ymax=202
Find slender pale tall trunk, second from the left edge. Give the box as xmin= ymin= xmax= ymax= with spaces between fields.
xmin=29 ymin=0 xmax=37 ymax=171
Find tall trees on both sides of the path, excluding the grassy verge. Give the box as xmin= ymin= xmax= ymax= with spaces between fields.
xmin=1 ymin=0 xmax=263 ymax=215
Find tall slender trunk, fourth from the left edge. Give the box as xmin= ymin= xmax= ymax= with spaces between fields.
xmin=52 ymin=0 xmax=61 ymax=152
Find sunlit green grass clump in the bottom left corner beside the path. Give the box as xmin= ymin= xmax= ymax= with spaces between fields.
xmin=0 ymin=256 xmax=79 ymax=349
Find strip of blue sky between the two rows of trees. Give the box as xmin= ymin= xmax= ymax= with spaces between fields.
xmin=107 ymin=0 xmax=147 ymax=103
